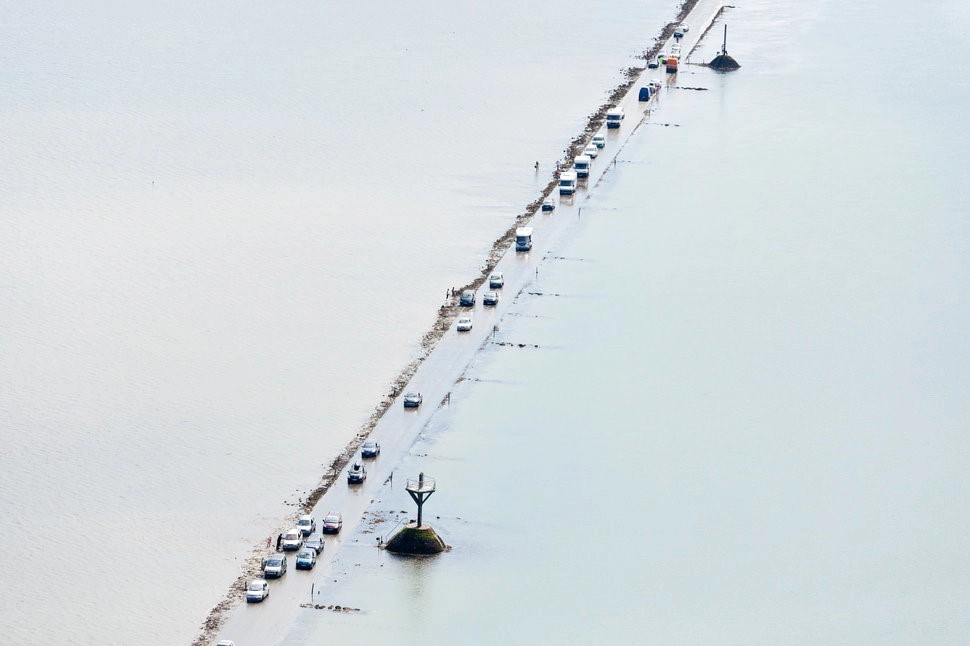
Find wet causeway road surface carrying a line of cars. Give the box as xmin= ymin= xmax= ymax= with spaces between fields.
xmin=212 ymin=0 xmax=722 ymax=646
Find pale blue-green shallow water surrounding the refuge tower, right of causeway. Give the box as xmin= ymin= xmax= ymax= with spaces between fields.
xmin=279 ymin=2 xmax=970 ymax=644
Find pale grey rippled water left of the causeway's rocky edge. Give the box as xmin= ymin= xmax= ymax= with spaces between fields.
xmin=0 ymin=0 xmax=675 ymax=643
